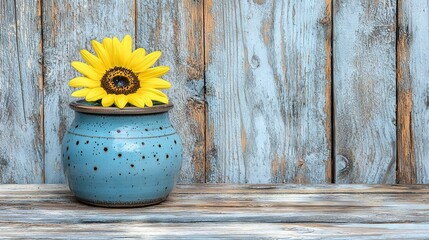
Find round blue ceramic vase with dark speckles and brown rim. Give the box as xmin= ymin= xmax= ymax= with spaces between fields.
xmin=62 ymin=101 xmax=182 ymax=207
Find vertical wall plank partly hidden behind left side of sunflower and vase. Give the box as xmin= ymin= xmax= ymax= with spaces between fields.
xmin=43 ymin=0 xmax=135 ymax=183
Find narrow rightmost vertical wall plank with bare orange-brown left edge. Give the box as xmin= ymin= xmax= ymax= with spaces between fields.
xmin=397 ymin=0 xmax=429 ymax=184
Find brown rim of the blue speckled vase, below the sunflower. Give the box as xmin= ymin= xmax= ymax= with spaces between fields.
xmin=69 ymin=99 xmax=174 ymax=115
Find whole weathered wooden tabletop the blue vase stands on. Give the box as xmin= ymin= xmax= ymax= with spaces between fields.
xmin=0 ymin=184 xmax=429 ymax=239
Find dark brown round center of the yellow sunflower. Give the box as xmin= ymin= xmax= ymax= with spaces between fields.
xmin=101 ymin=67 xmax=140 ymax=95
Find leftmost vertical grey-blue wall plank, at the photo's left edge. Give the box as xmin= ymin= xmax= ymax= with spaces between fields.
xmin=0 ymin=0 xmax=44 ymax=183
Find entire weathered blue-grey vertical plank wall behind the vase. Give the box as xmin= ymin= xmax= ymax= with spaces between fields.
xmin=0 ymin=0 xmax=429 ymax=183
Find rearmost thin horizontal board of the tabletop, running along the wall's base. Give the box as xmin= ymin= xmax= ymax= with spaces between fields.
xmin=0 ymin=183 xmax=429 ymax=195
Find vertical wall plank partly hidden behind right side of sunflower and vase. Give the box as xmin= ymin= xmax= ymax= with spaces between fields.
xmin=137 ymin=0 xmax=205 ymax=183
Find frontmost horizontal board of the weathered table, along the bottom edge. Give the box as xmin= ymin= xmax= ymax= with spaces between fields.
xmin=0 ymin=222 xmax=429 ymax=240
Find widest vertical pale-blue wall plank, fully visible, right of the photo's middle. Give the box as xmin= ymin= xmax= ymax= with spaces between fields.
xmin=204 ymin=0 xmax=331 ymax=183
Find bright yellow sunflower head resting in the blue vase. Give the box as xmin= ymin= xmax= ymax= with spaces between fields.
xmin=69 ymin=35 xmax=171 ymax=108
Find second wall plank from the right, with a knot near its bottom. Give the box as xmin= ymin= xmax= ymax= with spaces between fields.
xmin=333 ymin=0 xmax=396 ymax=183
